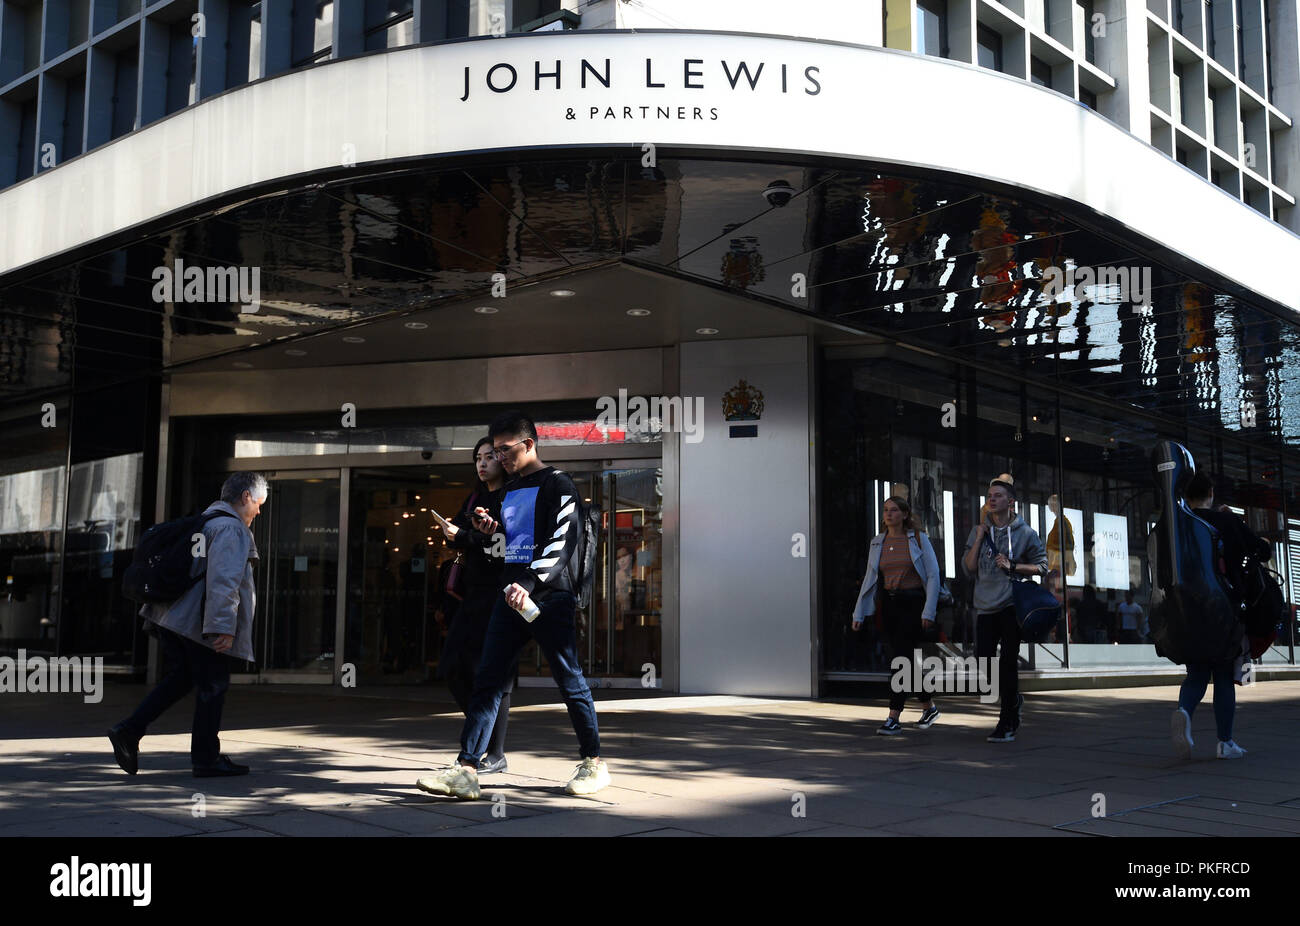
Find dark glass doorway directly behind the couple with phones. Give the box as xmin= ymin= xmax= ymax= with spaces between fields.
xmin=345 ymin=459 xmax=663 ymax=687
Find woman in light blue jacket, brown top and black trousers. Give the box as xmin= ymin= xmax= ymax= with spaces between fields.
xmin=853 ymin=496 xmax=940 ymax=736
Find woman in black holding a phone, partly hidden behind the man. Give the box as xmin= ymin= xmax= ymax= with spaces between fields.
xmin=433 ymin=437 xmax=515 ymax=775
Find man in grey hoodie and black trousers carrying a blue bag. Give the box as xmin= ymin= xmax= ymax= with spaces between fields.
xmin=962 ymin=473 xmax=1048 ymax=743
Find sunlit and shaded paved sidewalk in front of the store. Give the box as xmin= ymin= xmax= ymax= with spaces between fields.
xmin=0 ymin=681 xmax=1300 ymax=839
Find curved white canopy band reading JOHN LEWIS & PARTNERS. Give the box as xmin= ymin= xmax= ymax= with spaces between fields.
xmin=0 ymin=31 xmax=1300 ymax=313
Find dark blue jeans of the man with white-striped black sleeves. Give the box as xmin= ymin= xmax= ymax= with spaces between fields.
xmin=456 ymin=592 xmax=601 ymax=765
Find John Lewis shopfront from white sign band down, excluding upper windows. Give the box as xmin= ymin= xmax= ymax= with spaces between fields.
xmin=0 ymin=33 xmax=1300 ymax=695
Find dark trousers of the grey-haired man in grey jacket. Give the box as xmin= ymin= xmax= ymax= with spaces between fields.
xmin=122 ymin=627 xmax=230 ymax=765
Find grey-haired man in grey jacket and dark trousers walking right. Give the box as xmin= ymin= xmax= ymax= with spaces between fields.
xmin=108 ymin=472 xmax=267 ymax=778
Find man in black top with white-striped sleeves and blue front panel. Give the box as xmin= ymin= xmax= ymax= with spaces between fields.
xmin=416 ymin=411 xmax=610 ymax=800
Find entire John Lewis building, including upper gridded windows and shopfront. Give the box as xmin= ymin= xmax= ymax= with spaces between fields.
xmin=0 ymin=0 xmax=1300 ymax=696
